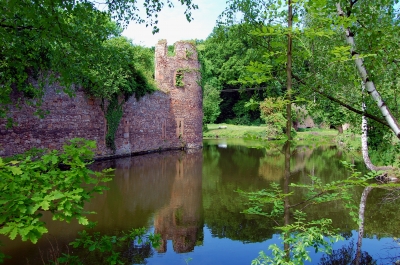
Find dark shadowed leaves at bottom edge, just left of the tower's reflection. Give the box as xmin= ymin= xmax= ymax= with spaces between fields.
xmin=52 ymin=223 xmax=161 ymax=265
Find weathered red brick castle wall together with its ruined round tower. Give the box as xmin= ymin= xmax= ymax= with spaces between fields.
xmin=0 ymin=41 xmax=203 ymax=157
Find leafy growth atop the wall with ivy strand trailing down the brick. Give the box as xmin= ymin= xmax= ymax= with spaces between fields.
xmin=80 ymin=37 xmax=155 ymax=151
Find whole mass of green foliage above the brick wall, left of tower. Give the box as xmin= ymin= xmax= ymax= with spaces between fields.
xmin=0 ymin=0 xmax=197 ymax=121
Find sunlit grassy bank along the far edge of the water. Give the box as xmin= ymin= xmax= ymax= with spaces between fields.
xmin=203 ymin=124 xmax=361 ymax=150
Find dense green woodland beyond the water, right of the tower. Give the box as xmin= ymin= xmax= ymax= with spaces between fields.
xmin=198 ymin=1 xmax=399 ymax=167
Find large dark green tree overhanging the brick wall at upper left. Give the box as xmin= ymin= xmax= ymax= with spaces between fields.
xmin=0 ymin=0 xmax=197 ymax=122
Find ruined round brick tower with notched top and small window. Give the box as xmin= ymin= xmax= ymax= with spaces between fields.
xmin=155 ymin=40 xmax=203 ymax=148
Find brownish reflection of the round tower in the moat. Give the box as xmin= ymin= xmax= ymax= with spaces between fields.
xmin=154 ymin=151 xmax=203 ymax=253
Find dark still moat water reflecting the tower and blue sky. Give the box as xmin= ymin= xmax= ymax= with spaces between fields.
xmin=1 ymin=140 xmax=400 ymax=265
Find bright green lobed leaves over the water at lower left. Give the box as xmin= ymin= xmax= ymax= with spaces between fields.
xmin=0 ymin=138 xmax=110 ymax=243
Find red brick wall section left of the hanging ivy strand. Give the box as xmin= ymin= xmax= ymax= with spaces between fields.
xmin=0 ymin=85 xmax=107 ymax=156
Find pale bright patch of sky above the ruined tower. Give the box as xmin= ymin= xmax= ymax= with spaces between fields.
xmin=122 ymin=0 xmax=226 ymax=47
